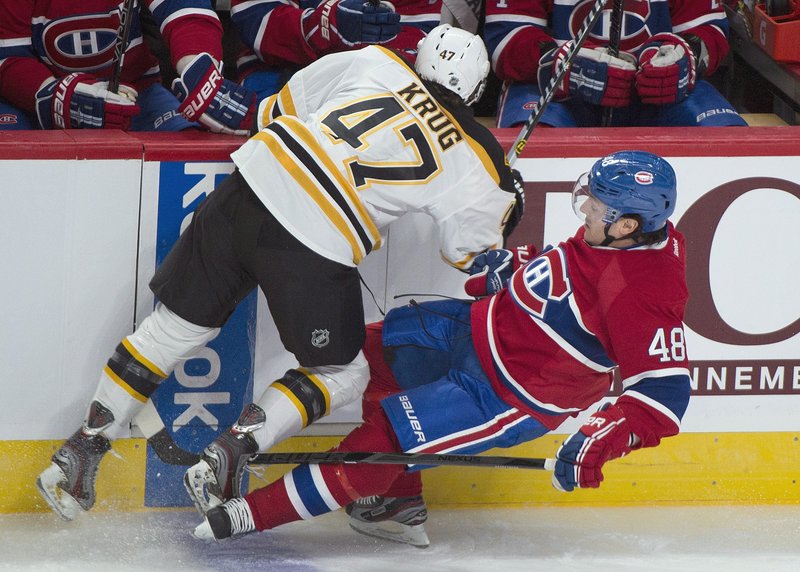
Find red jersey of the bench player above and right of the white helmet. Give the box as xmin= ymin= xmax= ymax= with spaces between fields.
xmin=484 ymin=0 xmax=728 ymax=81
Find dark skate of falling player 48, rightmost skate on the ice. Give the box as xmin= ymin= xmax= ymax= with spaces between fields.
xmin=345 ymin=496 xmax=430 ymax=548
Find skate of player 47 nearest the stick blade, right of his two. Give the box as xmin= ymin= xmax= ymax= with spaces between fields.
xmin=183 ymin=403 xmax=266 ymax=516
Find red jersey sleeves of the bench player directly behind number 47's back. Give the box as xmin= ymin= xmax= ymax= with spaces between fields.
xmin=231 ymin=0 xmax=442 ymax=66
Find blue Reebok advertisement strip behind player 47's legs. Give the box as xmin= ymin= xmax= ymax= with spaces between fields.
xmin=145 ymin=161 xmax=257 ymax=506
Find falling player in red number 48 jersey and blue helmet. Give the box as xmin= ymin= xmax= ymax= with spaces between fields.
xmin=195 ymin=151 xmax=690 ymax=546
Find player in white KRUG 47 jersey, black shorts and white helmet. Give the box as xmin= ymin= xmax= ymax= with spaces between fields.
xmin=37 ymin=25 xmax=522 ymax=520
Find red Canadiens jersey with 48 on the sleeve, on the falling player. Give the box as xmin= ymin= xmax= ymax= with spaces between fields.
xmin=472 ymin=225 xmax=689 ymax=433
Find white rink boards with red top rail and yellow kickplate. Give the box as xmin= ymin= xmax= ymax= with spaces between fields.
xmin=0 ymin=127 xmax=800 ymax=512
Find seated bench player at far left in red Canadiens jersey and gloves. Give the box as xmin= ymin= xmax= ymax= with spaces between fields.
xmin=0 ymin=0 xmax=256 ymax=135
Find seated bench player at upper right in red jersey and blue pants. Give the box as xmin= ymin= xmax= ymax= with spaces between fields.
xmin=484 ymin=0 xmax=746 ymax=127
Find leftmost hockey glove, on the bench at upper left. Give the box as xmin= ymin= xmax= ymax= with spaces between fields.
xmin=36 ymin=73 xmax=140 ymax=130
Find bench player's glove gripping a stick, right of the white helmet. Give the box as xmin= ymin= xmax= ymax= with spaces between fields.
xmin=538 ymin=41 xmax=636 ymax=107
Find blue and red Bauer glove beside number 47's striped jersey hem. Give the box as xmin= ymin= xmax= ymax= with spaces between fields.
xmin=172 ymin=53 xmax=256 ymax=135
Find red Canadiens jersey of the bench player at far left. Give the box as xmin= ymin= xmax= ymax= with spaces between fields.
xmin=0 ymin=0 xmax=222 ymax=112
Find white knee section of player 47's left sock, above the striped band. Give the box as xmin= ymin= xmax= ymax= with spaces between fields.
xmin=125 ymin=304 xmax=219 ymax=377
